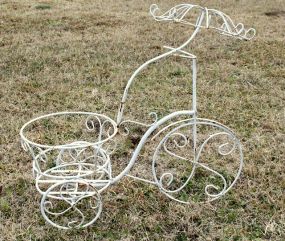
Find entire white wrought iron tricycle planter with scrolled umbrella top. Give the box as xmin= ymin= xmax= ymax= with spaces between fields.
xmin=20 ymin=4 xmax=255 ymax=229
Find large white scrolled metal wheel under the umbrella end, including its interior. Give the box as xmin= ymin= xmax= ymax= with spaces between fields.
xmin=152 ymin=119 xmax=243 ymax=203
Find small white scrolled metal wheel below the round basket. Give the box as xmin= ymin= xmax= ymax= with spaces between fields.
xmin=41 ymin=180 xmax=102 ymax=229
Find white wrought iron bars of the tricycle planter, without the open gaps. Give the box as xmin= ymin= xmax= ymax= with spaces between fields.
xmin=20 ymin=4 xmax=256 ymax=229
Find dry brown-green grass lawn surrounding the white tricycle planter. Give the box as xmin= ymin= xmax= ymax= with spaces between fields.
xmin=0 ymin=0 xmax=285 ymax=241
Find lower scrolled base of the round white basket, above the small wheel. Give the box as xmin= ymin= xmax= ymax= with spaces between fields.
xmin=33 ymin=146 xmax=112 ymax=197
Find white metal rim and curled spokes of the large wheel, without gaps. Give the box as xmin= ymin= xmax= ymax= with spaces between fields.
xmin=152 ymin=121 xmax=243 ymax=203
